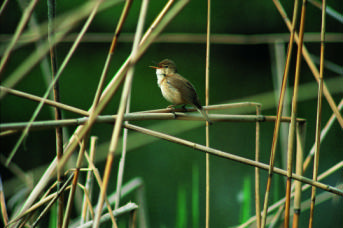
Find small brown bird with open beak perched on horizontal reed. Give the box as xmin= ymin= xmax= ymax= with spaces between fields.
xmin=151 ymin=59 xmax=212 ymax=124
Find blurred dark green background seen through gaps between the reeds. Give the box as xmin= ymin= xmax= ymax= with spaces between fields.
xmin=0 ymin=0 xmax=343 ymax=227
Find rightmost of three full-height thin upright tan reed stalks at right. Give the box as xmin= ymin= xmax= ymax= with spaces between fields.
xmin=309 ymin=0 xmax=326 ymax=228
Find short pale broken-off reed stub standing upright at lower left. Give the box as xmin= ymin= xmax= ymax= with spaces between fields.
xmin=80 ymin=136 xmax=98 ymax=225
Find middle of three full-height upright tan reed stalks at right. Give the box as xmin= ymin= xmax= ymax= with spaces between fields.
xmin=284 ymin=0 xmax=307 ymax=228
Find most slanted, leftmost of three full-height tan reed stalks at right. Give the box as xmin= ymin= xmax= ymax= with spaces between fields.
xmin=261 ymin=0 xmax=299 ymax=225
